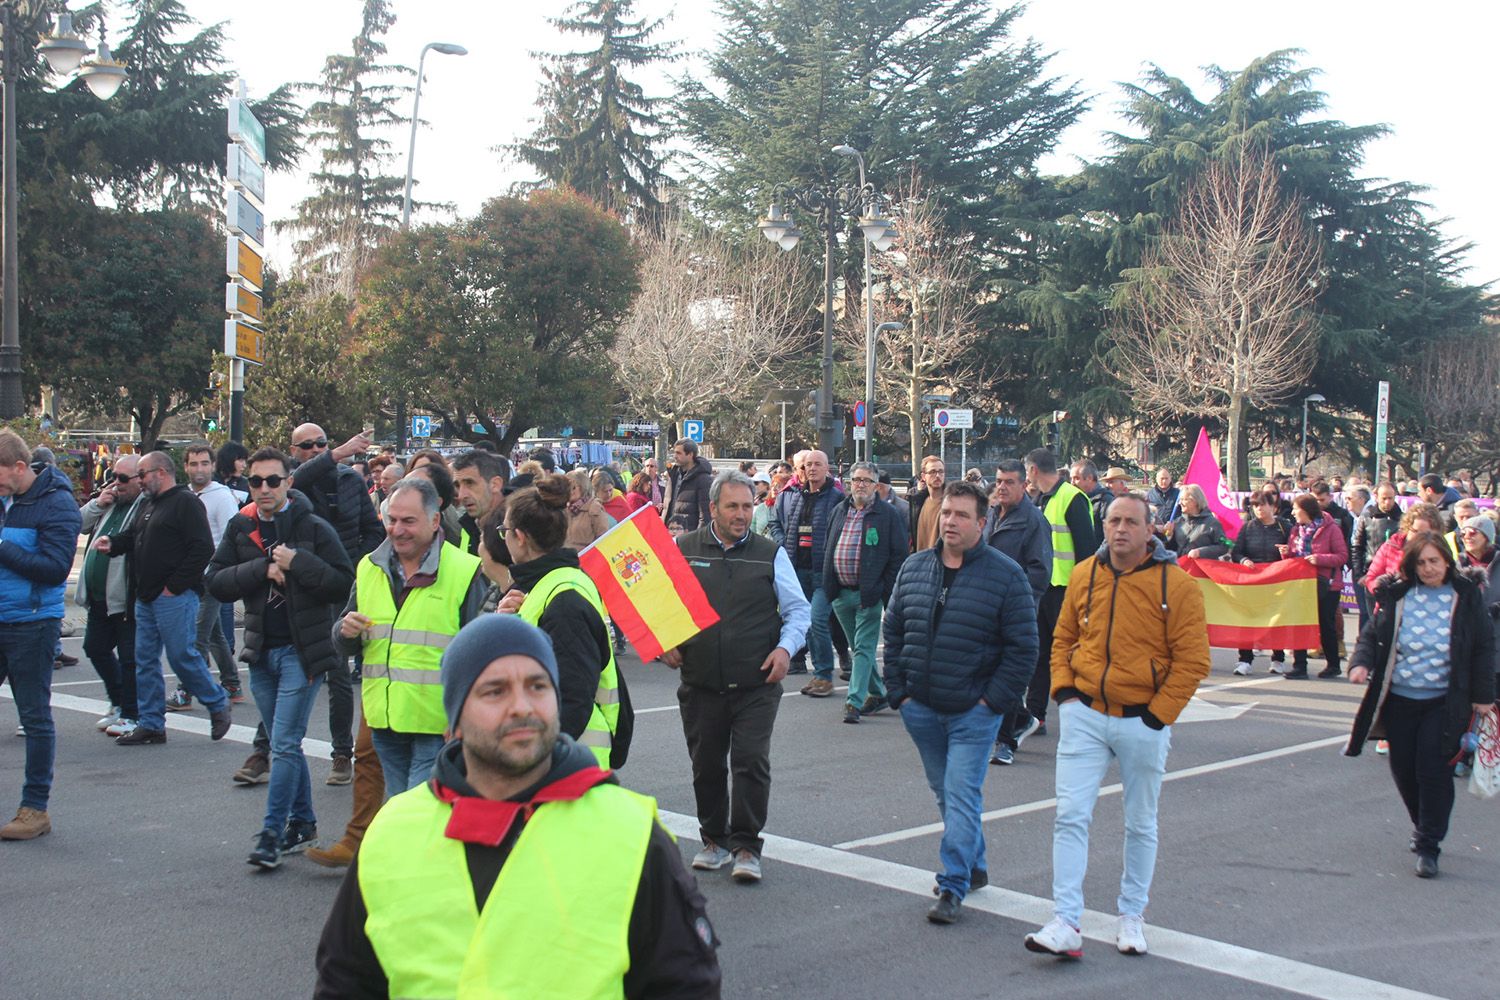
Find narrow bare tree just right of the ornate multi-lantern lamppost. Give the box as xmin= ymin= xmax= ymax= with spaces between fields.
xmin=840 ymin=174 xmax=989 ymax=475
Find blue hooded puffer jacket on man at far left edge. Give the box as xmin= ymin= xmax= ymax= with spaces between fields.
xmin=0 ymin=465 xmax=83 ymax=625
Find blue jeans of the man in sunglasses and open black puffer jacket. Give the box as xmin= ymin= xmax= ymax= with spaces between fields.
xmin=251 ymin=646 xmax=323 ymax=837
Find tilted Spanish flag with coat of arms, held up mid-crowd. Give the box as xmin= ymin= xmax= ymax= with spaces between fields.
xmin=578 ymin=505 xmax=719 ymax=663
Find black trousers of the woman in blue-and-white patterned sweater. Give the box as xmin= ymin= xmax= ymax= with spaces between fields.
xmin=1382 ymin=694 xmax=1454 ymax=858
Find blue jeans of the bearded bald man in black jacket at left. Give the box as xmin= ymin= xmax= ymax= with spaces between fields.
xmin=135 ymin=591 xmax=230 ymax=732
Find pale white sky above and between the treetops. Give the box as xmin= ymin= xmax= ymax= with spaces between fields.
xmin=185 ymin=0 xmax=1500 ymax=282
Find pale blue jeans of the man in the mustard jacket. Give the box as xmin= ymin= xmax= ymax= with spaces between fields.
xmin=1052 ymin=699 xmax=1172 ymax=927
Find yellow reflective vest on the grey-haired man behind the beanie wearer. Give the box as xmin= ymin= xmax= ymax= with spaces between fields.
xmin=354 ymin=546 xmax=479 ymax=733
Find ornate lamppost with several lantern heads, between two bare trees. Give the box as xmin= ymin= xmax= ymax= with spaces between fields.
xmin=759 ymin=158 xmax=890 ymax=460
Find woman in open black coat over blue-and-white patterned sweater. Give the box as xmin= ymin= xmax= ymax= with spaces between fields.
xmin=1344 ymin=532 xmax=1496 ymax=879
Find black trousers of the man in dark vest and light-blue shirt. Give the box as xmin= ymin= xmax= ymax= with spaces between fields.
xmin=677 ymin=684 xmax=782 ymax=858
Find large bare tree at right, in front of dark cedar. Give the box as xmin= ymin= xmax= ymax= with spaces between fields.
xmin=1115 ymin=150 xmax=1322 ymax=489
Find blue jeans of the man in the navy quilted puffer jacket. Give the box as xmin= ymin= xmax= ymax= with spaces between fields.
xmin=902 ymin=697 xmax=1001 ymax=900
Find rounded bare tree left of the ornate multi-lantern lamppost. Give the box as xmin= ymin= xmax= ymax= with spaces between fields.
xmin=611 ymin=225 xmax=813 ymax=458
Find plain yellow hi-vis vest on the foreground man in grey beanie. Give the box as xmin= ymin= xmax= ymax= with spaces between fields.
xmin=359 ymin=785 xmax=657 ymax=1000
